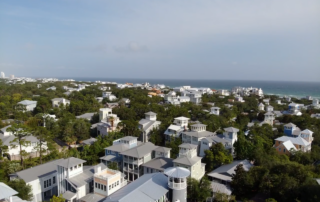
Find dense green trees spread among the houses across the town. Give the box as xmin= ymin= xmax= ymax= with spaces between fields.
xmin=0 ymin=81 xmax=320 ymax=201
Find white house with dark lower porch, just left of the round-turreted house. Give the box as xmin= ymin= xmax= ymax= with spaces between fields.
xmin=164 ymin=116 xmax=189 ymax=142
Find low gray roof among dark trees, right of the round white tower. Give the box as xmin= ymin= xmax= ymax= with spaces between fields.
xmin=208 ymin=160 xmax=253 ymax=181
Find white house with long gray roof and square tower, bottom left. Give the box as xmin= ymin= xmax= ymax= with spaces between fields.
xmin=10 ymin=157 xmax=106 ymax=202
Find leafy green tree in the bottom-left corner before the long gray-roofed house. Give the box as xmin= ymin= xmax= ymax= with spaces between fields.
xmin=8 ymin=179 xmax=33 ymax=201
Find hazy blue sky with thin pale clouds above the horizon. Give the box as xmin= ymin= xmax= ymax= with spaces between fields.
xmin=0 ymin=0 xmax=320 ymax=82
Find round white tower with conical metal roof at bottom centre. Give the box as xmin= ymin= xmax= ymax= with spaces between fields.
xmin=164 ymin=167 xmax=190 ymax=202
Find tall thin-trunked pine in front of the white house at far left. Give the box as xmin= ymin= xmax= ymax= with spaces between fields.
xmin=7 ymin=123 xmax=30 ymax=166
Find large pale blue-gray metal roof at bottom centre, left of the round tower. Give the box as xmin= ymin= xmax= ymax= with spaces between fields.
xmin=104 ymin=173 xmax=169 ymax=202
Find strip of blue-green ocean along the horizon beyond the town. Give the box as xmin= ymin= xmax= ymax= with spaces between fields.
xmin=58 ymin=77 xmax=320 ymax=98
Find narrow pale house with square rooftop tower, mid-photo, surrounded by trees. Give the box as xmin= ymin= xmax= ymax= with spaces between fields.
xmin=138 ymin=112 xmax=161 ymax=142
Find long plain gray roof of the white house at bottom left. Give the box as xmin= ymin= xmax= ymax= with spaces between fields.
xmin=16 ymin=159 xmax=64 ymax=183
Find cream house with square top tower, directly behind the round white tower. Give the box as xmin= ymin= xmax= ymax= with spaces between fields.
xmin=173 ymin=143 xmax=205 ymax=180
